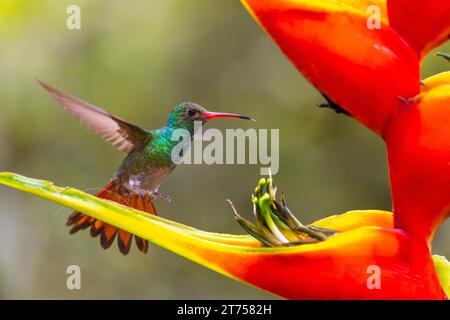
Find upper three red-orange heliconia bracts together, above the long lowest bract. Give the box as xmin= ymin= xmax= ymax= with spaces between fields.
xmin=242 ymin=0 xmax=450 ymax=243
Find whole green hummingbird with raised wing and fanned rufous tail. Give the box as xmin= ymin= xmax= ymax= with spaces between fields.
xmin=37 ymin=80 xmax=253 ymax=255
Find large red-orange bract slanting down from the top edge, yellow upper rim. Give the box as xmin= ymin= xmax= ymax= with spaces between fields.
xmin=245 ymin=0 xmax=419 ymax=134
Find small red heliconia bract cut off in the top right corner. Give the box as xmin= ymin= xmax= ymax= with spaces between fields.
xmin=387 ymin=0 xmax=450 ymax=57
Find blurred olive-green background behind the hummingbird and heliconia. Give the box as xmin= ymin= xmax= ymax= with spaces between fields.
xmin=0 ymin=0 xmax=450 ymax=299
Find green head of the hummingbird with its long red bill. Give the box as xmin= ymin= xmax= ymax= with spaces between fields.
xmin=167 ymin=102 xmax=254 ymax=132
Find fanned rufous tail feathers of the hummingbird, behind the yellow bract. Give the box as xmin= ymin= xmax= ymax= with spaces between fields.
xmin=66 ymin=180 xmax=156 ymax=255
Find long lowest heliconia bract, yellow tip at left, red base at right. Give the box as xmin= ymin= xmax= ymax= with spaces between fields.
xmin=0 ymin=173 xmax=444 ymax=299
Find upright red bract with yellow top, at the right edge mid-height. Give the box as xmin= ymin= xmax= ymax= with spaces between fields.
xmin=385 ymin=72 xmax=450 ymax=242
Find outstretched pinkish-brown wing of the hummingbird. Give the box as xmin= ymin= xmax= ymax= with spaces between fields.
xmin=37 ymin=80 xmax=151 ymax=152
